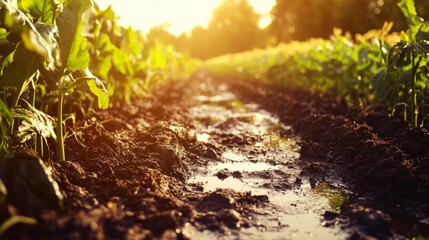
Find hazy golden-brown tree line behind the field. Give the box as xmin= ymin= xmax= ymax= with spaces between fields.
xmin=149 ymin=0 xmax=429 ymax=59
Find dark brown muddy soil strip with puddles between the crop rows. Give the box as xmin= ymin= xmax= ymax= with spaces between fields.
xmin=5 ymin=71 xmax=429 ymax=239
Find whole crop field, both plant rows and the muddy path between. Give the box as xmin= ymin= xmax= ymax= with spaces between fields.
xmin=0 ymin=0 xmax=429 ymax=239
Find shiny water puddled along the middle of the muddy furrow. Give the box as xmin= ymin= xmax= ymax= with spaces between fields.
xmin=189 ymin=82 xmax=345 ymax=239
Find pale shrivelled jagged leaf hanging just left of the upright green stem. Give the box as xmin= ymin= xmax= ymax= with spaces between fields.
xmin=12 ymin=100 xmax=56 ymax=143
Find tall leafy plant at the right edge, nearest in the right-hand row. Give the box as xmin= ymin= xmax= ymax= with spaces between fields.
xmin=374 ymin=0 xmax=429 ymax=127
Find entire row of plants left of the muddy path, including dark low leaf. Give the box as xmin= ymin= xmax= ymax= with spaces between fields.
xmin=0 ymin=0 xmax=197 ymax=234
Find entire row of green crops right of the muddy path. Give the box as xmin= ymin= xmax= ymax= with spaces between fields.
xmin=207 ymin=0 xmax=429 ymax=127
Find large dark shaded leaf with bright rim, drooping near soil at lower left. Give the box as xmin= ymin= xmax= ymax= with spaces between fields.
xmin=0 ymin=153 xmax=63 ymax=215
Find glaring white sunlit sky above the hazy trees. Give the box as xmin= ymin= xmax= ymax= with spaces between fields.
xmin=96 ymin=0 xmax=275 ymax=35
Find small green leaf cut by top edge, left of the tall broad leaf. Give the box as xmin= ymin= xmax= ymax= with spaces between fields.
xmin=18 ymin=0 xmax=65 ymax=24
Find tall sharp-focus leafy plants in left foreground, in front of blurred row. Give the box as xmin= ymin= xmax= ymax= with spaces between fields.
xmin=0 ymin=0 xmax=108 ymax=160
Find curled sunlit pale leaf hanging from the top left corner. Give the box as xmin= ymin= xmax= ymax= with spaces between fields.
xmin=0 ymin=1 xmax=53 ymax=59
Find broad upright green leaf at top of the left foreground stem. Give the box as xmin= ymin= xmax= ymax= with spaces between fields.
xmin=57 ymin=0 xmax=91 ymax=72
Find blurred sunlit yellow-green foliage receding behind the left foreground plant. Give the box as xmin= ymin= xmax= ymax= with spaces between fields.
xmin=89 ymin=3 xmax=197 ymax=104
